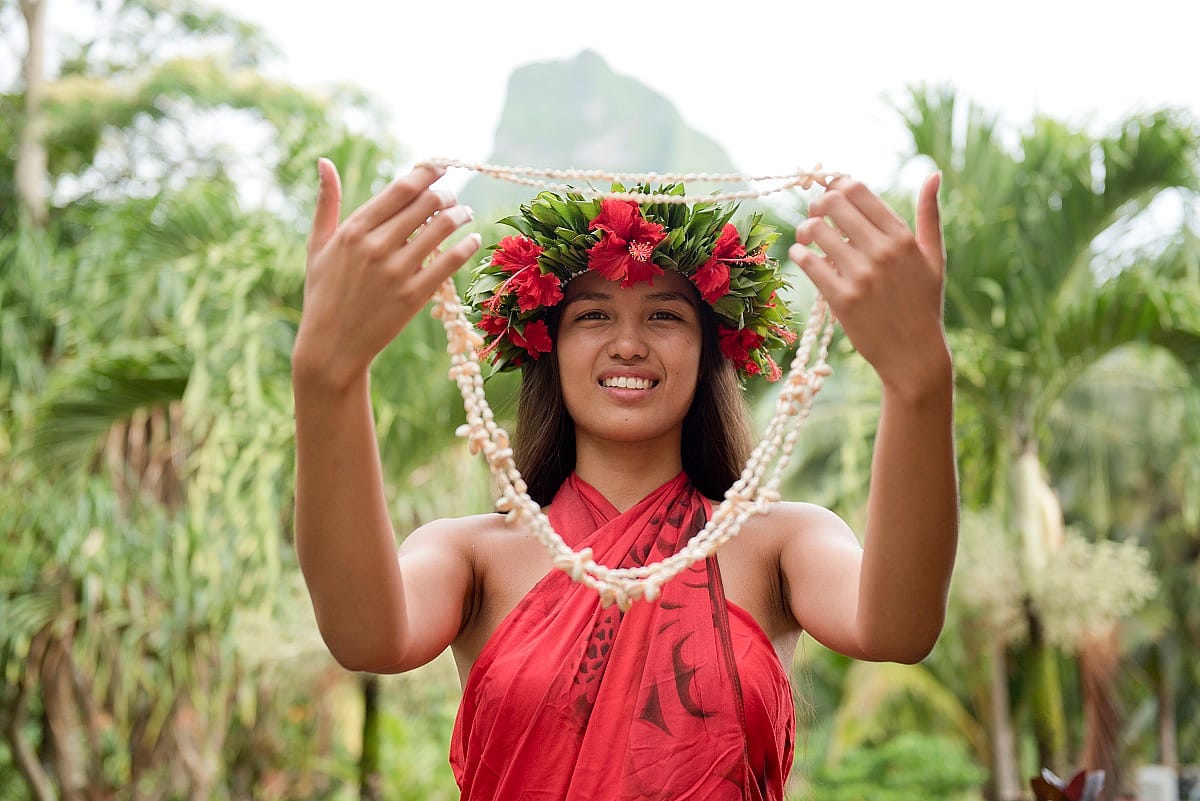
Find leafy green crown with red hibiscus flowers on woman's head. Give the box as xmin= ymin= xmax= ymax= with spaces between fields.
xmin=467 ymin=183 xmax=796 ymax=381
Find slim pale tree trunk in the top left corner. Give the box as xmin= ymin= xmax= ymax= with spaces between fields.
xmin=17 ymin=0 xmax=49 ymax=228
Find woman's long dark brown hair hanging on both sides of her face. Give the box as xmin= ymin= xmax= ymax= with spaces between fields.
xmin=512 ymin=299 xmax=754 ymax=506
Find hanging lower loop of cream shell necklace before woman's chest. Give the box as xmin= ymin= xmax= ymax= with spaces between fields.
xmin=431 ymin=278 xmax=835 ymax=612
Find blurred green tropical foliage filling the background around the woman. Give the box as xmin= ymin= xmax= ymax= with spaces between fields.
xmin=0 ymin=0 xmax=1200 ymax=801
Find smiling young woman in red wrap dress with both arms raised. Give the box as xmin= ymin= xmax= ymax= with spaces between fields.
xmin=293 ymin=161 xmax=958 ymax=800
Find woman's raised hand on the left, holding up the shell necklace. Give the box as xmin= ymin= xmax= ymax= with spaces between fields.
xmin=292 ymin=158 xmax=480 ymax=390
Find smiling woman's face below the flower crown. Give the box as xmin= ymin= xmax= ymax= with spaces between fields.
xmin=554 ymin=270 xmax=701 ymax=447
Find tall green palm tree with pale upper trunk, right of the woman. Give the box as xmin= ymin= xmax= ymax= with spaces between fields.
xmin=905 ymin=89 xmax=1200 ymax=797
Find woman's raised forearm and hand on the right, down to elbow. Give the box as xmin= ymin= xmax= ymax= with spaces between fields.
xmin=784 ymin=174 xmax=958 ymax=663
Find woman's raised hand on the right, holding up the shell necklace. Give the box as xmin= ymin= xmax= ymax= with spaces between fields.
xmin=788 ymin=174 xmax=949 ymax=396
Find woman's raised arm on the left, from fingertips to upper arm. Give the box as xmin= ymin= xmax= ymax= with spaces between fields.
xmin=292 ymin=159 xmax=479 ymax=673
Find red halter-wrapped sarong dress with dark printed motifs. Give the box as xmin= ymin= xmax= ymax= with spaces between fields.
xmin=450 ymin=474 xmax=796 ymax=801
